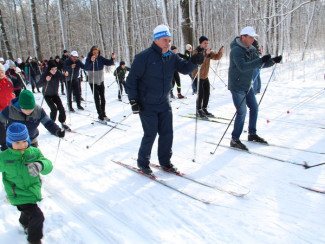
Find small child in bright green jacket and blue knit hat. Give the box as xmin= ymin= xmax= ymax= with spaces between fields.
xmin=0 ymin=122 xmax=53 ymax=243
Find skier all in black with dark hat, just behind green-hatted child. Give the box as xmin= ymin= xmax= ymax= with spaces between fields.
xmin=39 ymin=60 xmax=70 ymax=130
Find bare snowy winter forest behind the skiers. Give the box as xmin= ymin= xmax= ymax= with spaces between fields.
xmin=0 ymin=0 xmax=325 ymax=64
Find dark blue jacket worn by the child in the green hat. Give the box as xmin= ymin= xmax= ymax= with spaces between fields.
xmin=0 ymin=97 xmax=60 ymax=141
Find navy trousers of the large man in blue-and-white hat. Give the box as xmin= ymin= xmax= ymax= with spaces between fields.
xmin=138 ymin=101 xmax=173 ymax=167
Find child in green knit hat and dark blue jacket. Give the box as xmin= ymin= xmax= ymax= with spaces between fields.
xmin=0 ymin=90 xmax=65 ymax=150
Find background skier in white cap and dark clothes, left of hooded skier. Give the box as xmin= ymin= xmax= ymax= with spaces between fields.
xmin=63 ymin=51 xmax=85 ymax=112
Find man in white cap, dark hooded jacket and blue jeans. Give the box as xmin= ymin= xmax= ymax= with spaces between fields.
xmin=228 ymin=26 xmax=282 ymax=150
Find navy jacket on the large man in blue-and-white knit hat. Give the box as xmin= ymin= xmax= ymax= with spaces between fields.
xmin=126 ymin=43 xmax=197 ymax=104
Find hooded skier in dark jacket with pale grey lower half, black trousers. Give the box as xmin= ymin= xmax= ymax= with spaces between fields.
xmin=85 ymin=46 xmax=115 ymax=123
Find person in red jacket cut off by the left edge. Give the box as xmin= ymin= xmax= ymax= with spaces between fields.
xmin=0 ymin=63 xmax=15 ymax=151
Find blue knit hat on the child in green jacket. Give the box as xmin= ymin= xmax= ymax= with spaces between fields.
xmin=6 ymin=122 xmax=31 ymax=148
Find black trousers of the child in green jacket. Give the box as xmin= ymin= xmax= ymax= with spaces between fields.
xmin=17 ymin=204 xmax=44 ymax=242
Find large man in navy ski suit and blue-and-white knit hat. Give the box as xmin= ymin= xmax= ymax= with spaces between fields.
xmin=126 ymin=25 xmax=204 ymax=175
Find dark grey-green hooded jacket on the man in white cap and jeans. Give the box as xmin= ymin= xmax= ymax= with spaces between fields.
xmin=228 ymin=37 xmax=273 ymax=91
